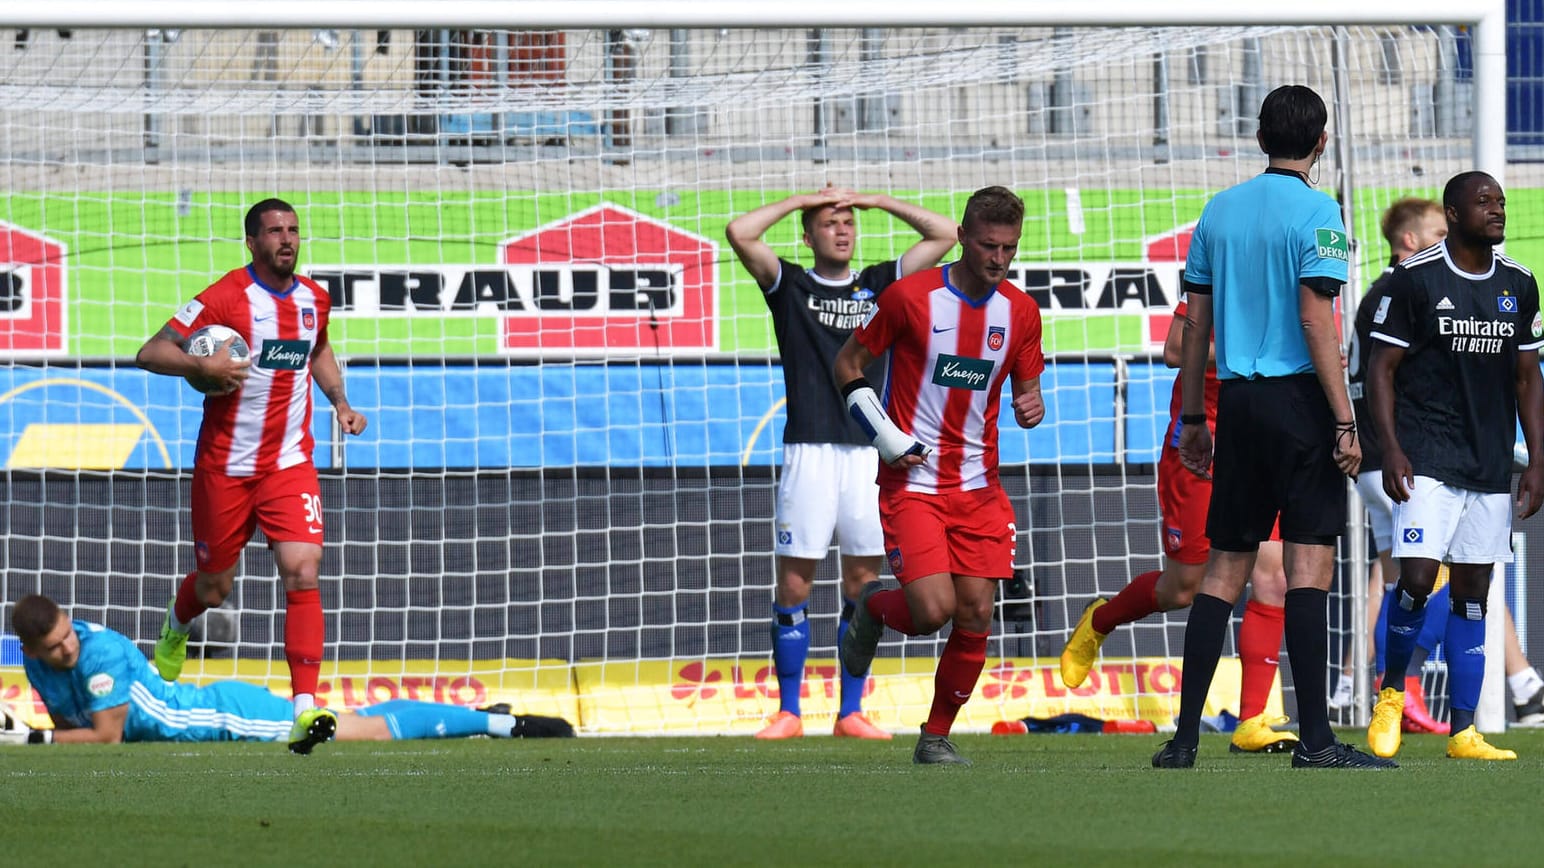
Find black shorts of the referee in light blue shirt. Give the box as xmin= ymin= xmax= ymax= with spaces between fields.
xmin=1206 ymin=374 xmax=1346 ymax=551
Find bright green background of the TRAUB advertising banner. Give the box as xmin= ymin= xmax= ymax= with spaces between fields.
xmin=18 ymin=188 xmax=1544 ymax=358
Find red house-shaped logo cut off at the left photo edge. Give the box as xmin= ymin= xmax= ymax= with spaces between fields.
xmin=0 ymin=222 xmax=68 ymax=358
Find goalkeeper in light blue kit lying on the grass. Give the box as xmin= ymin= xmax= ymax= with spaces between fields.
xmin=0 ymin=595 xmax=574 ymax=754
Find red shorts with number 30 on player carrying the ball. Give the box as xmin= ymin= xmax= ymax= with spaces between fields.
xmin=193 ymin=462 xmax=323 ymax=573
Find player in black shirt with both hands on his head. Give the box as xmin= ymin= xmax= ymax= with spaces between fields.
xmin=726 ymin=187 xmax=957 ymax=740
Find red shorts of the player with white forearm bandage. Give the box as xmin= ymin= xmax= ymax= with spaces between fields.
xmin=879 ymin=485 xmax=1019 ymax=585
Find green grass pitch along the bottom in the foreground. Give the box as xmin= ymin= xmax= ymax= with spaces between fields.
xmin=0 ymin=731 xmax=1544 ymax=868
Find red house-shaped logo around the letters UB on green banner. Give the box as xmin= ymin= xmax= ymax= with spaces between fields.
xmin=499 ymin=204 xmax=718 ymax=355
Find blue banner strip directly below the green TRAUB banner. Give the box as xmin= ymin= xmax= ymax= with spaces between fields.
xmin=0 ymin=361 xmax=1173 ymax=470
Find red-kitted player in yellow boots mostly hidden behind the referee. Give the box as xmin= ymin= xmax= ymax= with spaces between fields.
xmin=1061 ymin=298 xmax=1297 ymax=754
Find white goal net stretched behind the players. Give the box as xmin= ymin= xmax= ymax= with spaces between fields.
xmin=0 ymin=10 xmax=1500 ymax=734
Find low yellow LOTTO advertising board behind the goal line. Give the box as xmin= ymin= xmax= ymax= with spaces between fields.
xmin=0 ymin=656 xmax=1282 ymax=735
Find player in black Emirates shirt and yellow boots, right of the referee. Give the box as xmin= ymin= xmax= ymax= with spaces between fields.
xmin=1366 ymin=171 xmax=1544 ymax=760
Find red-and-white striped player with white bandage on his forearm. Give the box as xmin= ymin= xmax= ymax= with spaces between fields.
xmin=834 ymin=187 xmax=1045 ymax=765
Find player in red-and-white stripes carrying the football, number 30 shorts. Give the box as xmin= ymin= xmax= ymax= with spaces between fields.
xmin=136 ymin=199 xmax=366 ymax=754
